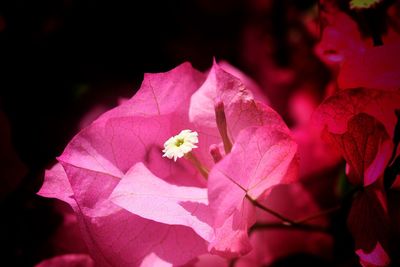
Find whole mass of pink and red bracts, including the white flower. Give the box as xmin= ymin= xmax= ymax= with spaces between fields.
xmin=38 ymin=1 xmax=400 ymax=267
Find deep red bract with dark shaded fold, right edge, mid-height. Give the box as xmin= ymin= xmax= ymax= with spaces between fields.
xmin=314 ymin=89 xmax=400 ymax=185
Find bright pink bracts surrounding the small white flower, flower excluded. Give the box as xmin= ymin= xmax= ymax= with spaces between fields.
xmin=39 ymin=63 xmax=297 ymax=266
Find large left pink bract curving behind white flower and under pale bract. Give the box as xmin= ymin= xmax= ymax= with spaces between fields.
xmin=43 ymin=64 xmax=216 ymax=266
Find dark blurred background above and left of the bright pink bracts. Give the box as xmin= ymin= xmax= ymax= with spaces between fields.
xmin=0 ymin=0 xmax=340 ymax=266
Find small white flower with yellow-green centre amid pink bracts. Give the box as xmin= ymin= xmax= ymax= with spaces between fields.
xmin=162 ymin=130 xmax=199 ymax=161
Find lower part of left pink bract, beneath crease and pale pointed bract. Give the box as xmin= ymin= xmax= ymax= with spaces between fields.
xmin=58 ymin=159 xmax=207 ymax=266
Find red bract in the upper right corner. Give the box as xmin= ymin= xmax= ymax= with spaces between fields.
xmin=315 ymin=8 xmax=400 ymax=90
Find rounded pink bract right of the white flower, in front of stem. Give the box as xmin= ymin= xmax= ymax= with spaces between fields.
xmin=208 ymin=126 xmax=298 ymax=256
